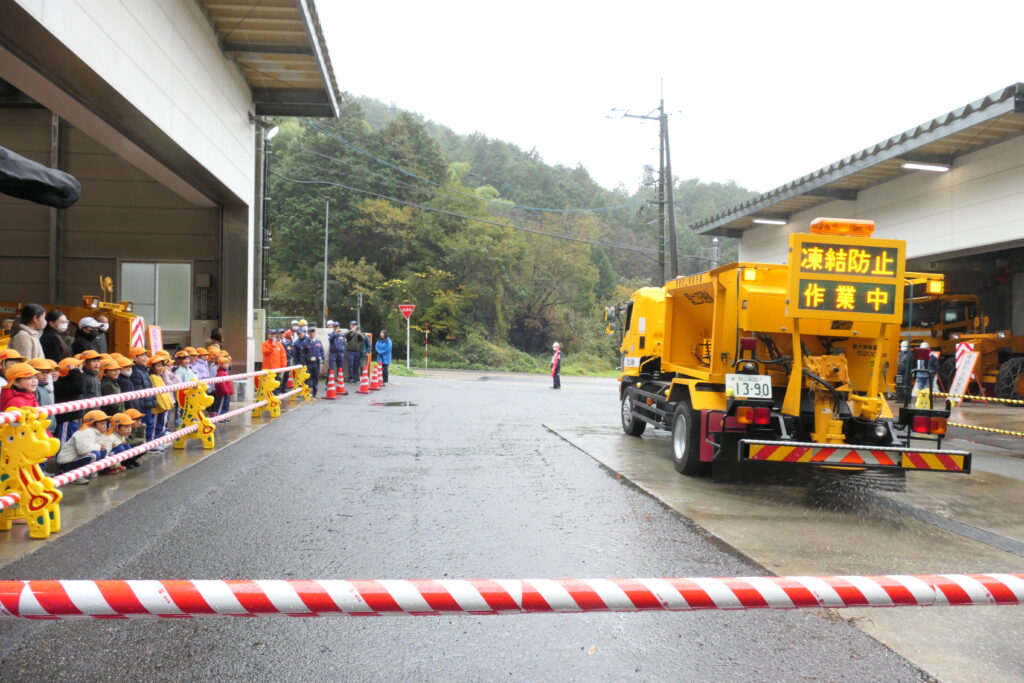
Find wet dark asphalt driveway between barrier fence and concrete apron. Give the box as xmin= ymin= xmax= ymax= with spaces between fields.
xmin=0 ymin=373 xmax=926 ymax=681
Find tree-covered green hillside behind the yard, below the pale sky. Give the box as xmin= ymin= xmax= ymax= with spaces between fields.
xmin=268 ymin=96 xmax=753 ymax=367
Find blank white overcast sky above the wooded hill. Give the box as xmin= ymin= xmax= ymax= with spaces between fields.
xmin=316 ymin=0 xmax=1024 ymax=197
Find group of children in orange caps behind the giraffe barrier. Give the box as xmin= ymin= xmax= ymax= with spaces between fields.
xmin=0 ymin=346 xmax=234 ymax=483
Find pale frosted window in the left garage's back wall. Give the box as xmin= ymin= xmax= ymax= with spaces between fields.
xmin=120 ymin=261 xmax=191 ymax=332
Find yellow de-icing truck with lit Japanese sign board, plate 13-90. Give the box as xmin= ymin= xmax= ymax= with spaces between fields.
xmin=612 ymin=218 xmax=971 ymax=489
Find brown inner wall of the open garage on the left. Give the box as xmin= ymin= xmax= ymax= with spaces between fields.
xmin=0 ymin=109 xmax=220 ymax=325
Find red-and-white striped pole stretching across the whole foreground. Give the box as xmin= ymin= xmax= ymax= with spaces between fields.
xmin=0 ymin=573 xmax=1024 ymax=620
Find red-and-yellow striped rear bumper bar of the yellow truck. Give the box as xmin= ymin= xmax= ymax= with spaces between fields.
xmin=739 ymin=439 xmax=971 ymax=474
